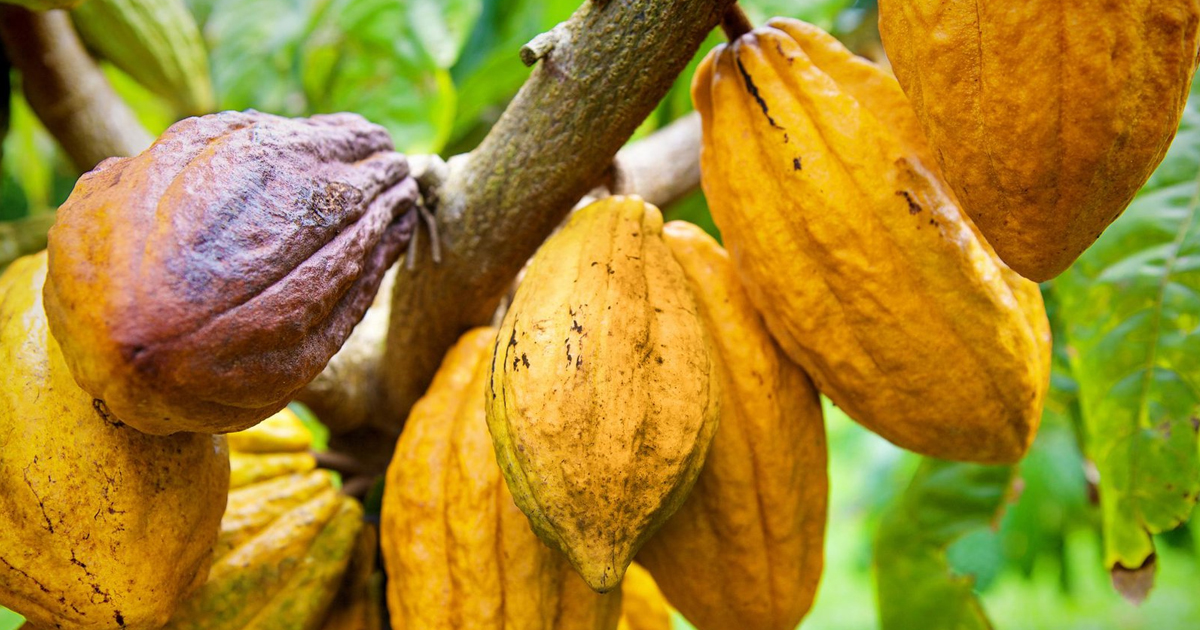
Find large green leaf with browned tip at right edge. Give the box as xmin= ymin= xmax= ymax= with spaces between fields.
xmin=1054 ymin=79 xmax=1200 ymax=580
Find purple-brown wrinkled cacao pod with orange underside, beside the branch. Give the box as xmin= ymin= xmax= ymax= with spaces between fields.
xmin=46 ymin=112 xmax=418 ymax=434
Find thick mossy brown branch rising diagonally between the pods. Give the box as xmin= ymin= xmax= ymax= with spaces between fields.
xmin=383 ymin=0 xmax=732 ymax=431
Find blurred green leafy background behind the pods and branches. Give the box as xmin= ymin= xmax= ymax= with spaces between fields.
xmin=0 ymin=0 xmax=1200 ymax=630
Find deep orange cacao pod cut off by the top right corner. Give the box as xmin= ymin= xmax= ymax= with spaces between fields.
xmin=880 ymin=0 xmax=1200 ymax=281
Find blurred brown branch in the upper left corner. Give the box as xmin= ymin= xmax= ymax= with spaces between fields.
xmin=0 ymin=4 xmax=154 ymax=170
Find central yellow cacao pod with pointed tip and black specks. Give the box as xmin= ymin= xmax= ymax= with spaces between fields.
xmin=487 ymin=197 xmax=720 ymax=593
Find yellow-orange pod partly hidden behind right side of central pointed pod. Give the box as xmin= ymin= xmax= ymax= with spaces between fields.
xmin=643 ymin=221 xmax=828 ymax=630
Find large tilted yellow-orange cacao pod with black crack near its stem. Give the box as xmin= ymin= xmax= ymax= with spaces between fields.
xmin=692 ymin=19 xmax=1050 ymax=463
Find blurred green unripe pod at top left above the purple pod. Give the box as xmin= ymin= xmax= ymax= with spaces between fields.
xmin=71 ymin=0 xmax=215 ymax=115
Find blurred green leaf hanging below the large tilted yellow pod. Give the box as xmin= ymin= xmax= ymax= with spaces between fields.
xmin=875 ymin=457 xmax=1014 ymax=630
